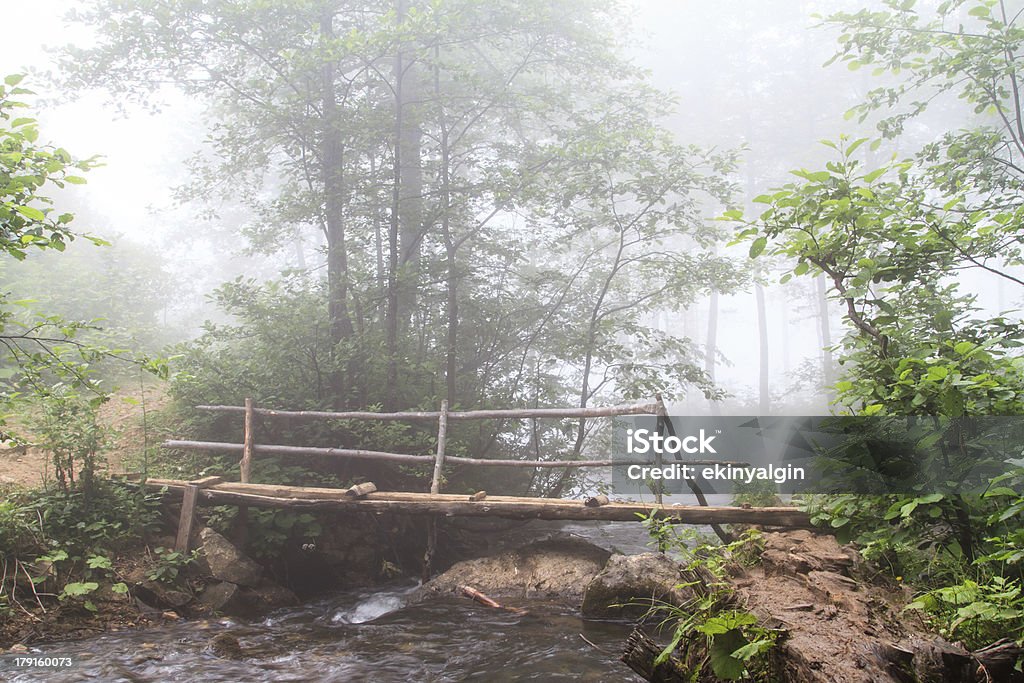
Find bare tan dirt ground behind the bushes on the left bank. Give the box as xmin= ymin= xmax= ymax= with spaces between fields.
xmin=0 ymin=382 xmax=170 ymax=488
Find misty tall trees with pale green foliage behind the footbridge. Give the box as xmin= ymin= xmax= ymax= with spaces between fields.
xmin=60 ymin=0 xmax=741 ymax=501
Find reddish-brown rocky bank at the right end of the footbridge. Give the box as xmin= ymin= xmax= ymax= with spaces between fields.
xmin=733 ymin=530 xmax=974 ymax=683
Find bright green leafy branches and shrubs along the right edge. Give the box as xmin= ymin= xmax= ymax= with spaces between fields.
xmin=725 ymin=0 xmax=1024 ymax=646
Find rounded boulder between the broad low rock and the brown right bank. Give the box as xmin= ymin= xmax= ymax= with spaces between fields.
xmin=583 ymin=553 xmax=692 ymax=618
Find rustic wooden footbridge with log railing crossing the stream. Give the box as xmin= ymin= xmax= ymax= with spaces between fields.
xmin=144 ymin=397 xmax=810 ymax=550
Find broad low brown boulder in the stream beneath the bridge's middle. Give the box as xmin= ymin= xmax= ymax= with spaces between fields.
xmin=421 ymin=537 xmax=610 ymax=604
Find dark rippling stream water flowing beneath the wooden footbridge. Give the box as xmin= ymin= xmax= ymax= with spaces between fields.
xmin=6 ymin=523 xmax=663 ymax=683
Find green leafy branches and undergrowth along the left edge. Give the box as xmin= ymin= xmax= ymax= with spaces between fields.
xmin=0 ymin=76 xmax=172 ymax=626
